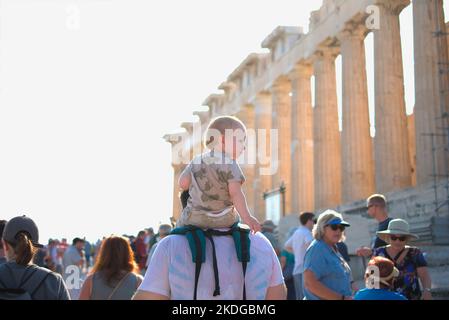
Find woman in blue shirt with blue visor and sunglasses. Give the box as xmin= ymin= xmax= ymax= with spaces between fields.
xmin=303 ymin=210 xmax=352 ymax=300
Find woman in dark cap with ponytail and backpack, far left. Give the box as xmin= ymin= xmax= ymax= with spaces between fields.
xmin=0 ymin=216 xmax=70 ymax=300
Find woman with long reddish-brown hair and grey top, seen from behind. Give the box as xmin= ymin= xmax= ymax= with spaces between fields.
xmin=79 ymin=236 xmax=143 ymax=300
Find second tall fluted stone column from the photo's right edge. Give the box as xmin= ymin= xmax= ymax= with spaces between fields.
xmin=374 ymin=0 xmax=411 ymax=193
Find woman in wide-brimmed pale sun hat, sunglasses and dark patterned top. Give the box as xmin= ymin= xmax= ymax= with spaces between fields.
xmin=373 ymin=219 xmax=432 ymax=300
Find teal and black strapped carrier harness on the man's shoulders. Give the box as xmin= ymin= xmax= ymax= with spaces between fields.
xmin=170 ymin=222 xmax=251 ymax=300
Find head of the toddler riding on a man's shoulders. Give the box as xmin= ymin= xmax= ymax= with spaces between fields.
xmin=204 ymin=116 xmax=246 ymax=159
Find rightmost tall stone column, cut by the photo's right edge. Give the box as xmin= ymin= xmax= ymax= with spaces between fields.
xmin=413 ymin=0 xmax=449 ymax=184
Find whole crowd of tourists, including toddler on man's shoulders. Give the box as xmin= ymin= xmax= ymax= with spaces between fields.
xmin=0 ymin=116 xmax=432 ymax=300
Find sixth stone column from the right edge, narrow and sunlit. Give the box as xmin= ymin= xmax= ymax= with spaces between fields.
xmin=272 ymin=78 xmax=292 ymax=214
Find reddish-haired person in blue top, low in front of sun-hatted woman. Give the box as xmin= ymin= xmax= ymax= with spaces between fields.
xmin=354 ymin=257 xmax=407 ymax=300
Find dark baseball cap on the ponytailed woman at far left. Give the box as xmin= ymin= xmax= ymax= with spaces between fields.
xmin=3 ymin=216 xmax=43 ymax=248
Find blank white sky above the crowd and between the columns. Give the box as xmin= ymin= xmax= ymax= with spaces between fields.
xmin=0 ymin=0 xmax=448 ymax=242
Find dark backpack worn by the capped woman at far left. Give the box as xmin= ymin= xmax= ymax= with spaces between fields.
xmin=0 ymin=264 xmax=51 ymax=300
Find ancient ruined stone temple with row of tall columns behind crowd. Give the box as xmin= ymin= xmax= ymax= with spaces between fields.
xmin=164 ymin=0 xmax=449 ymax=251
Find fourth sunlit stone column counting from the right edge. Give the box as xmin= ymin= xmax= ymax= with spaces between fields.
xmin=313 ymin=47 xmax=341 ymax=209
